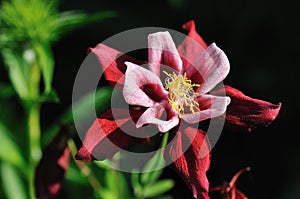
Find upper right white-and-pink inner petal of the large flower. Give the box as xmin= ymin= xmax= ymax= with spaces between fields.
xmin=186 ymin=43 xmax=230 ymax=95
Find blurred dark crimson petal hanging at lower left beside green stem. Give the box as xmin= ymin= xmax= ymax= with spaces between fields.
xmin=35 ymin=129 xmax=70 ymax=199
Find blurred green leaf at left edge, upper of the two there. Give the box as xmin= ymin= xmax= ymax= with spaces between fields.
xmin=0 ymin=123 xmax=26 ymax=169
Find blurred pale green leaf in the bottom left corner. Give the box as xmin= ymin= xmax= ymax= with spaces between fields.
xmin=1 ymin=161 xmax=27 ymax=199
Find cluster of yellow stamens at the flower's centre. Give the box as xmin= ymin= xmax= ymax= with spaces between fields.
xmin=163 ymin=71 xmax=200 ymax=117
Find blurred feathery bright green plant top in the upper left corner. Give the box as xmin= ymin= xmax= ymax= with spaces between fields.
xmin=0 ymin=0 xmax=115 ymax=97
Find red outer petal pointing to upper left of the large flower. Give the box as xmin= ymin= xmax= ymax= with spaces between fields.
xmin=89 ymin=43 xmax=141 ymax=86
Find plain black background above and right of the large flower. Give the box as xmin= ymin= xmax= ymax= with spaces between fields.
xmin=2 ymin=0 xmax=300 ymax=199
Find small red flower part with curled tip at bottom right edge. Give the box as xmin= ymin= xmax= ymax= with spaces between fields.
xmin=210 ymin=167 xmax=250 ymax=199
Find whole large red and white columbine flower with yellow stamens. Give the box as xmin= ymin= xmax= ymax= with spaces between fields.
xmin=76 ymin=21 xmax=280 ymax=198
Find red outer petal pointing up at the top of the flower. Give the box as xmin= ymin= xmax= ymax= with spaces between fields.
xmin=178 ymin=20 xmax=207 ymax=70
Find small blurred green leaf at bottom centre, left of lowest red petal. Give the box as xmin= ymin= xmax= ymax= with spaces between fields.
xmin=143 ymin=179 xmax=174 ymax=198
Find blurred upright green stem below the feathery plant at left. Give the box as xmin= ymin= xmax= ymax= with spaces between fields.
xmin=28 ymin=102 xmax=41 ymax=199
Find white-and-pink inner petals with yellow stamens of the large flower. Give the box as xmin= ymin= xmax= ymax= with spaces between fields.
xmin=123 ymin=32 xmax=230 ymax=132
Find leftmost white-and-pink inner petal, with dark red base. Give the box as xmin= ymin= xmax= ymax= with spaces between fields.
xmin=123 ymin=62 xmax=167 ymax=107
